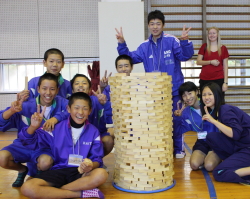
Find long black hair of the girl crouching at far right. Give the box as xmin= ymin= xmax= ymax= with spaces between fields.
xmin=201 ymin=82 xmax=225 ymax=117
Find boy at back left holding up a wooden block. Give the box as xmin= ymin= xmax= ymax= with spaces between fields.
xmin=18 ymin=48 xmax=71 ymax=99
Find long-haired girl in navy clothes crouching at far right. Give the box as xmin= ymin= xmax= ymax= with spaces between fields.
xmin=201 ymin=82 xmax=250 ymax=185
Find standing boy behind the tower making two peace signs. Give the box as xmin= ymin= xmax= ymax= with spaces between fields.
xmin=116 ymin=10 xmax=194 ymax=158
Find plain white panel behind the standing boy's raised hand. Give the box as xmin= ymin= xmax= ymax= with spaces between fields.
xmin=98 ymin=2 xmax=144 ymax=77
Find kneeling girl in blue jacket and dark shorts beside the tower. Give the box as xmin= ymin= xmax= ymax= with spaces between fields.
xmin=174 ymin=82 xmax=220 ymax=171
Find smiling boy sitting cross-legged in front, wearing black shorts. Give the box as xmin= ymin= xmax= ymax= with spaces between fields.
xmin=19 ymin=92 xmax=108 ymax=199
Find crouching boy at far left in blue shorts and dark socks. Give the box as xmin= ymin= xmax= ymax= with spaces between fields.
xmin=0 ymin=73 xmax=69 ymax=187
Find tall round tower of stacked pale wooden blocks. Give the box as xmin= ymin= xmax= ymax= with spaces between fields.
xmin=109 ymin=72 xmax=174 ymax=191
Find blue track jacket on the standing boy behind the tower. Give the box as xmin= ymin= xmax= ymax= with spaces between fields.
xmin=117 ymin=32 xmax=194 ymax=96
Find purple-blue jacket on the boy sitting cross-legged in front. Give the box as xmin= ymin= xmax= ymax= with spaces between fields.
xmin=18 ymin=119 xmax=103 ymax=170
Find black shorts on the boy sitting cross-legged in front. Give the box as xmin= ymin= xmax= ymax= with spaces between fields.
xmin=35 ymin=167 xmax=83 ymax=188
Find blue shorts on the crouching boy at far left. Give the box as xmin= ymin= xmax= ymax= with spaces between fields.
xmin=2 ymin=139 xmax=54 ymax=163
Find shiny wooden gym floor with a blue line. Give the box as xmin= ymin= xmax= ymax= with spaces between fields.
xmin=0 ymin=132 xmax=250 ymax=199
